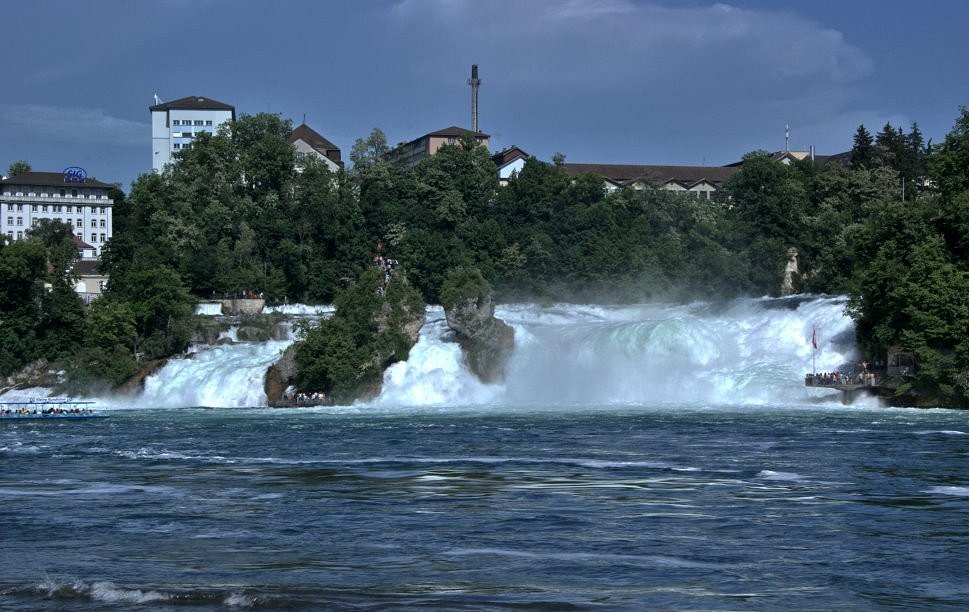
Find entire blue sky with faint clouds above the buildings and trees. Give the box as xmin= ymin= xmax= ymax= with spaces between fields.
xmin=0 ymin=0 xmax=969 ymax=191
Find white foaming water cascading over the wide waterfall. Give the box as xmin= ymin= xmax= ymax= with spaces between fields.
xmin=81 ymin=296 xmax=860 ymax=407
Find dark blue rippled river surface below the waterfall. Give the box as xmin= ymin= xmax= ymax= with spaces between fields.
xmin=0 ymin=406 xmax=969 ymax=610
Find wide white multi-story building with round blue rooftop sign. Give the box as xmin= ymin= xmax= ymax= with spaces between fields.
xmin=0 ymin=172 xmax=114 ymax=259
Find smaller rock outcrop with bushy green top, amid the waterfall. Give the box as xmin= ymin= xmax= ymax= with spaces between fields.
xmin=441 ymin=268 xmax=515 ymax=383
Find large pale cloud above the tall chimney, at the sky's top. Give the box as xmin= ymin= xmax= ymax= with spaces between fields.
xmin=393 ymin=0 xmax=872 ymax=90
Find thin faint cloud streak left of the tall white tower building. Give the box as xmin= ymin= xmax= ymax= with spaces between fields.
xmin=0 ymin=104 xmax=151 ymax=146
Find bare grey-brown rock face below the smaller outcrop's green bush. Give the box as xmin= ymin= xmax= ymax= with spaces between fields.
xmin=444 ymin=293 xmax=515 ymax=383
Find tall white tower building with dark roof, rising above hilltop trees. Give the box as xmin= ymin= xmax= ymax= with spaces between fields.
xmin=148 ymin=96 xmax=236 ymax=172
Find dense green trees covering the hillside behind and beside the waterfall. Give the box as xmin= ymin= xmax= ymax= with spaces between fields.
xmin=0 ymin=109 xmax=969 ymax=406
